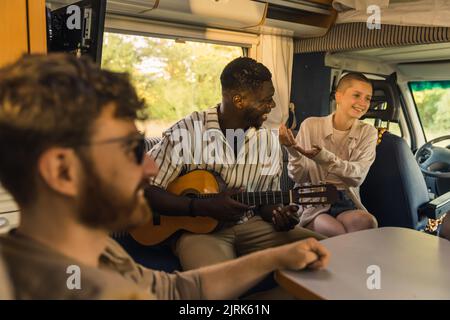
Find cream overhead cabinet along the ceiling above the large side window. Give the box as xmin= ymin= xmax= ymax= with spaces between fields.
xmin=47 ymin=0 xmax=336 ymax=38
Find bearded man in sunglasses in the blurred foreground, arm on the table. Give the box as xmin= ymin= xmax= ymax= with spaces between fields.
xmin=0 ymin=54 xmax=328 ymax=299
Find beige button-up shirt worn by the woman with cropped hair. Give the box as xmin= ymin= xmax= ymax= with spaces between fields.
xmin=288 ymin=114 xmax=378 ymax=225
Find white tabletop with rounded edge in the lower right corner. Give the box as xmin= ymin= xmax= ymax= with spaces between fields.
xmin=275 ymin=227 xmax=450 ymax=299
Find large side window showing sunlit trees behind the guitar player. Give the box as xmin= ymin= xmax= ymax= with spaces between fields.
xmin=102 ymin=32 xmax=243 ymax=136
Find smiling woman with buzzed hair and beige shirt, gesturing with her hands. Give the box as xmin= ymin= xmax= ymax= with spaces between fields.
xmin=280 ymin=73 xmax=377 ymax=237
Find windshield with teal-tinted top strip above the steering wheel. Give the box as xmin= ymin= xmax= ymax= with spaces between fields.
xmin=409 ymin=80 xmax=450 ymax=141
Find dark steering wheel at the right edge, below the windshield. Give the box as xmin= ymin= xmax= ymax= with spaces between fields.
xmin=416 ymin=135 xmax=450 ymax=178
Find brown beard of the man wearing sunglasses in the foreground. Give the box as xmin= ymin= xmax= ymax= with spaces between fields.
xmin=74 ymin=157 xmax=150 ymax=232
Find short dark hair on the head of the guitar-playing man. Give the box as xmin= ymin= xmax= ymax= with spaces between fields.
xmin=220 ymin=57 xmax=272 ymax=91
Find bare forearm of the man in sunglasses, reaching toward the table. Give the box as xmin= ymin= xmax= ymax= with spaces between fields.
xmin=199 ymin=249 xmax=280 ymax=300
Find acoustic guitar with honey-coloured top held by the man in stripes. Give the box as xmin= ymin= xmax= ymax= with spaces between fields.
xmin=130 ymin=170 xmax=338 ymax=245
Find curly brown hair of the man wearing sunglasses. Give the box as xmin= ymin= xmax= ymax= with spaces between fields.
xmin=0 ymin=53 xmax=144 ymax=206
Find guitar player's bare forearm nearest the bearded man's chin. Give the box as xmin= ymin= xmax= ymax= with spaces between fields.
xmin=145 ymin=185 xmax=191 ymax=216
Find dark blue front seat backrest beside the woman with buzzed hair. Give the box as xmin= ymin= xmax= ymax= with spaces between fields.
xmin=361 ymin=132 xmax=429 ymax=229
